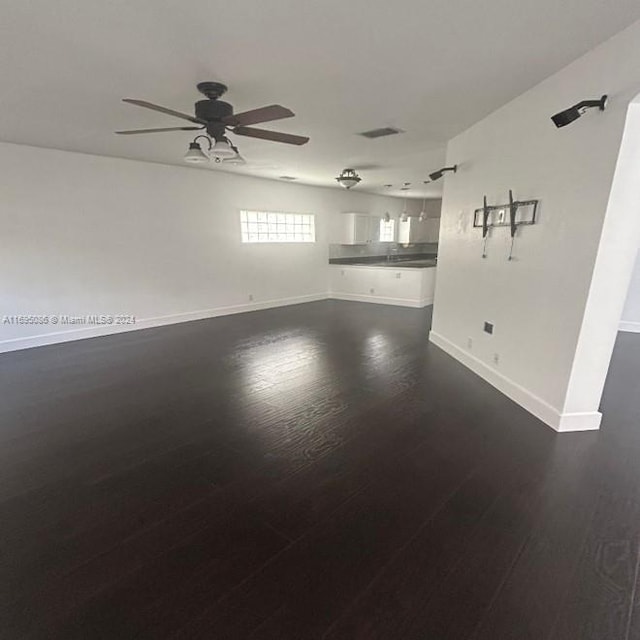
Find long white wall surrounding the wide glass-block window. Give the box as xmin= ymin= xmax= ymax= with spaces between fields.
xmin=0 ymin=144 xmax=402 ymax=351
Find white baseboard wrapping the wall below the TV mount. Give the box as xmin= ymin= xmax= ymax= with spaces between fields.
xmin=429 ymin=331 xmax=602 ymax=432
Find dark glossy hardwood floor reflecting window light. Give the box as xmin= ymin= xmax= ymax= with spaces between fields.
xmin=0 ymin=301 xmax=640 ymax=640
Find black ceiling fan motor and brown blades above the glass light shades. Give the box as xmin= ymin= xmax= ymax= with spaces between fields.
xmin=116 ymin=82 xmax=309 ymax=145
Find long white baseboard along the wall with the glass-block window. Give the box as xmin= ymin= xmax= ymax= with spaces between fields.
xmin=0 ymin=293 xmax=328 ymax=353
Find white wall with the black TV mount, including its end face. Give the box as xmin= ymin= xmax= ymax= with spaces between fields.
xmin=431 ymin=18 xmax=640 ymax=430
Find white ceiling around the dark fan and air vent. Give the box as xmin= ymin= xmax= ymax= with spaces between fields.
xmin=0 ymin=0 xmax=640 ymax=196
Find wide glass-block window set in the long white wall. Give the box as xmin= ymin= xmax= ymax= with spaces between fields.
xmin=240 ymin=211 xmax=316 ymax=242
